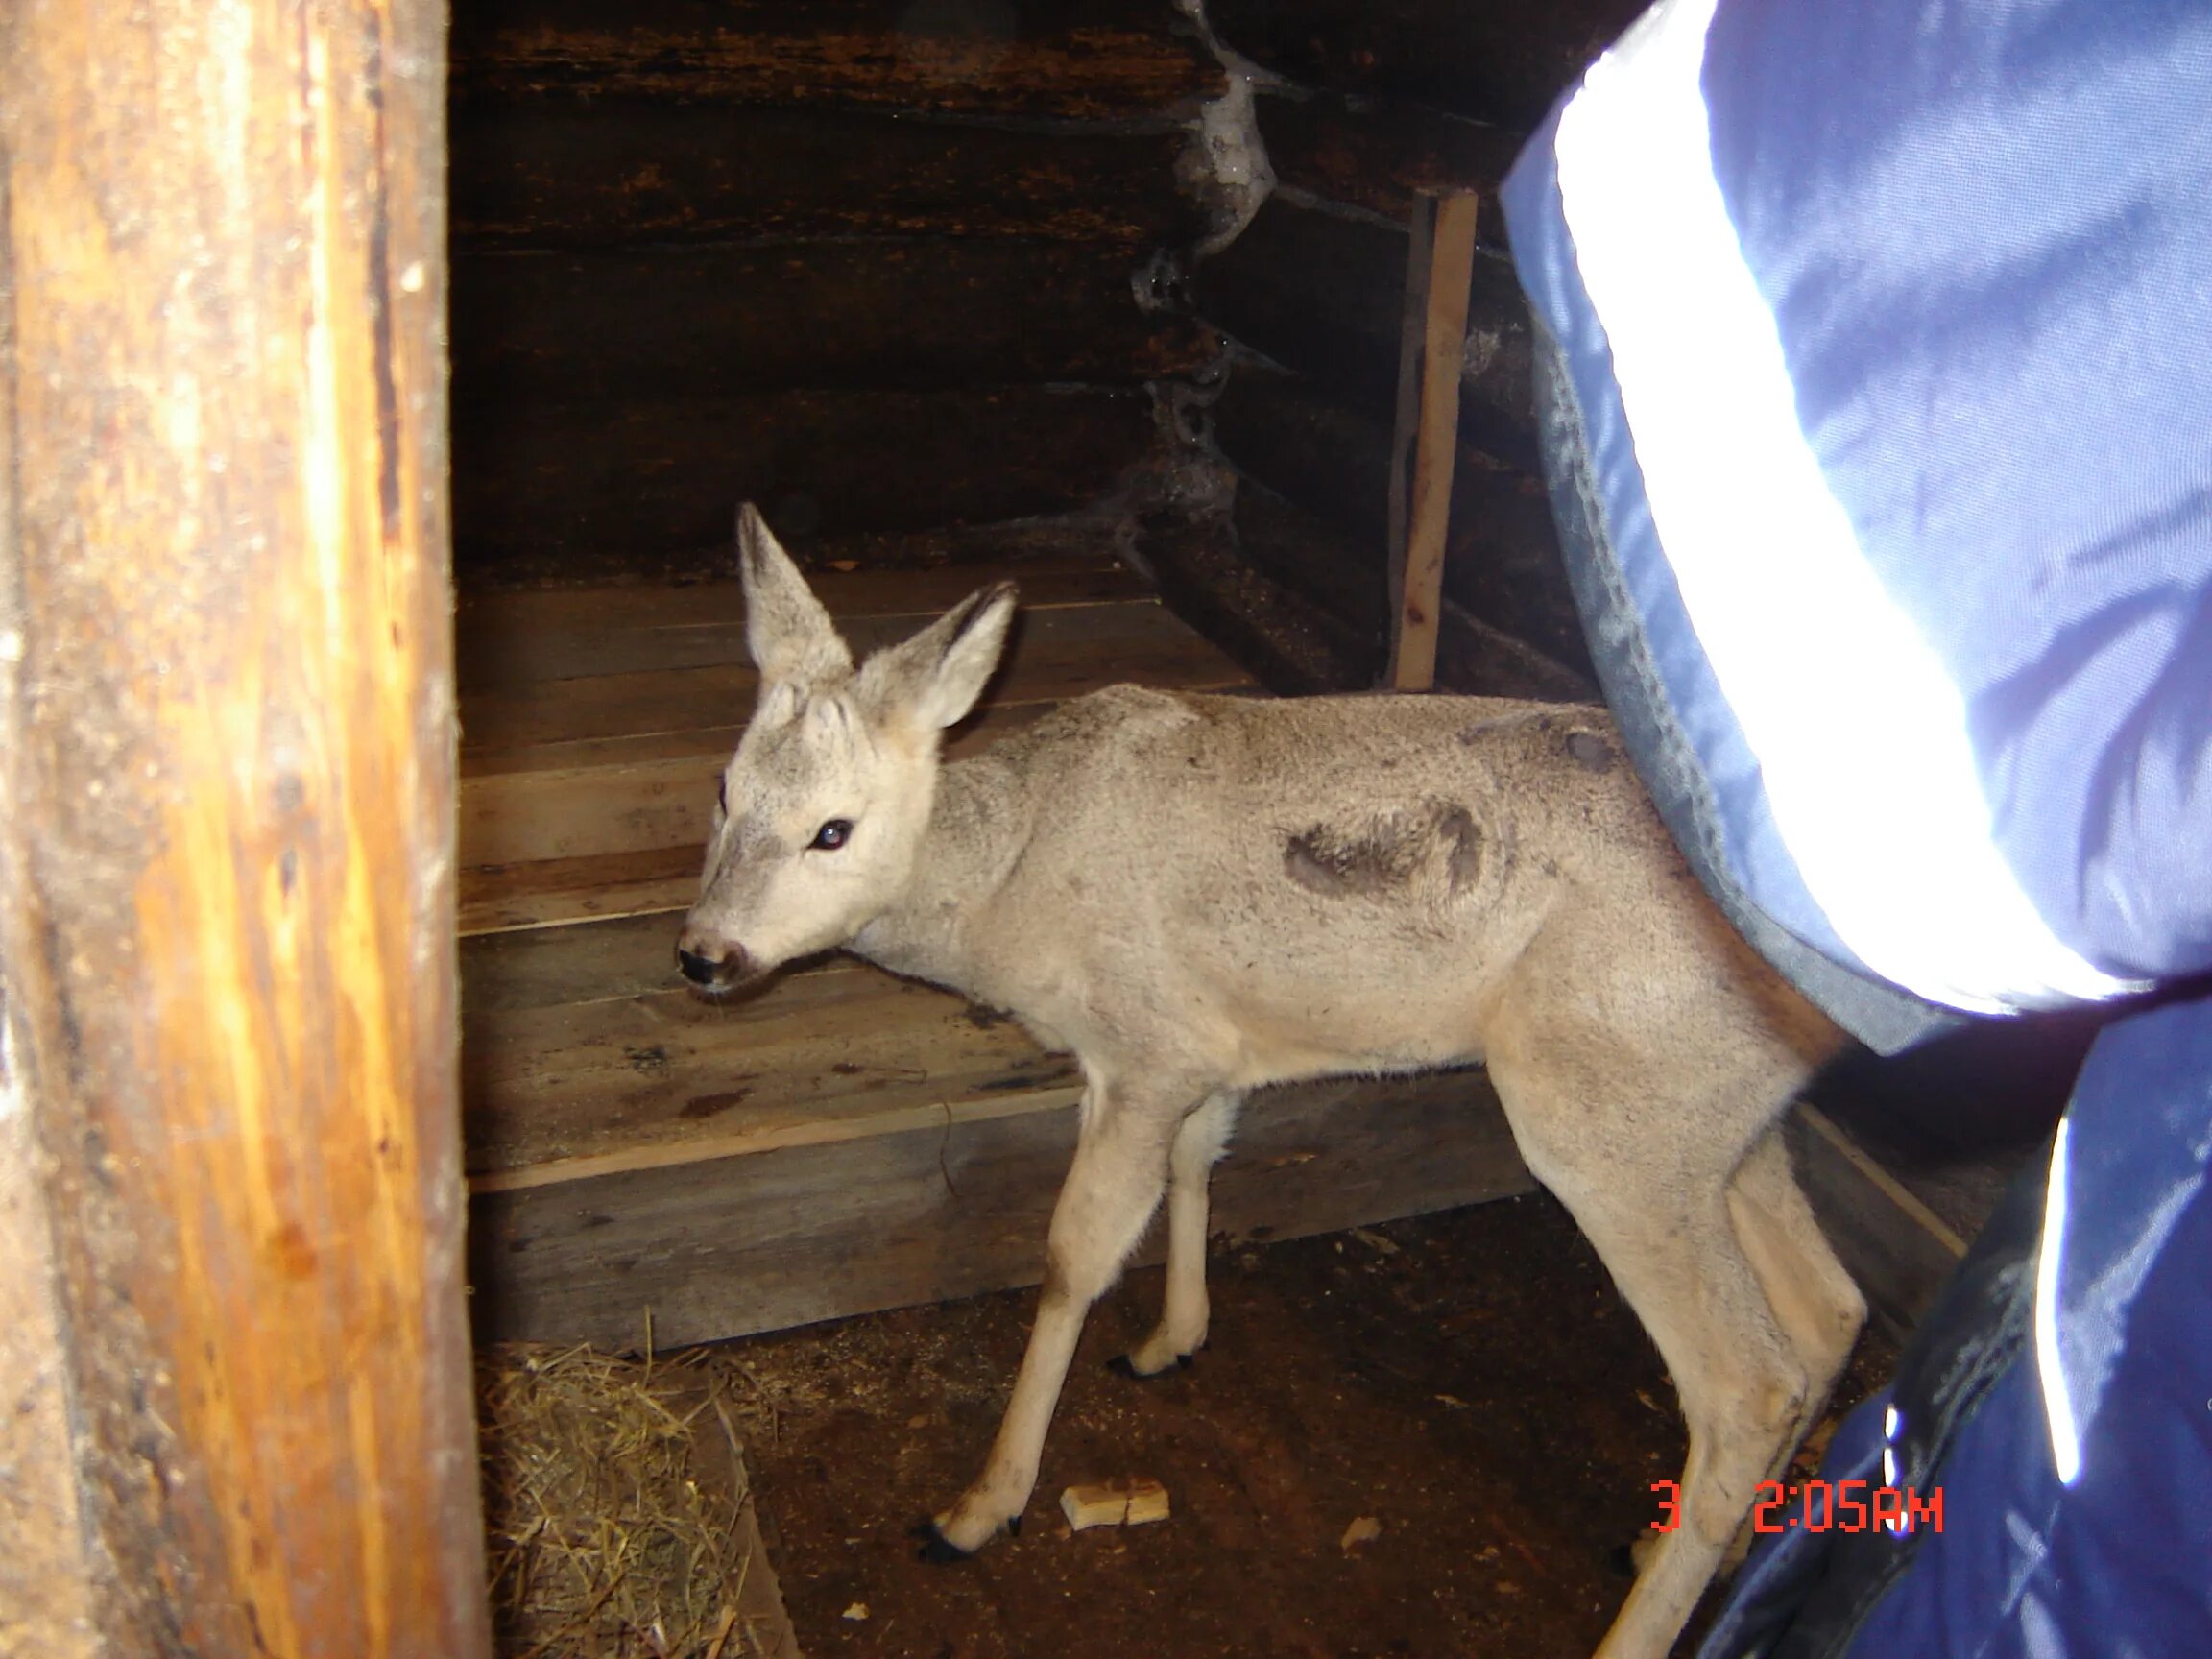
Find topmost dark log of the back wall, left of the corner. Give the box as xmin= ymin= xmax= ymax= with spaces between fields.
xmin=440 ymin=0 xmax=1223 ymax=119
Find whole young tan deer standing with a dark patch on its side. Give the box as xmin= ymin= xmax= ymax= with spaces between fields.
xmin=679 ymin=509 xmax=1864 ymax=1659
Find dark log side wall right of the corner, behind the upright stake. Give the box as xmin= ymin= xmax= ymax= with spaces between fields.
xmin=1148 ymin=0 xmax=1642 ymax=697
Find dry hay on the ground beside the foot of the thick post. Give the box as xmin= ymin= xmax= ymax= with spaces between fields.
xmin=475 ymin=1343 xmax=777 ymax=1659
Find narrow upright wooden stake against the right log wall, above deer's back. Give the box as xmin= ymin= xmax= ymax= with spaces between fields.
xmin=1389 ymin=195 xmax=1478 ymax=690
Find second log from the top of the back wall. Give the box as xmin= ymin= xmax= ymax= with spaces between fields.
xmin=449 ymin=93 xmax=1206 ymax=248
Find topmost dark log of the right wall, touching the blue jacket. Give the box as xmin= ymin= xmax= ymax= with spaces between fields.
xmin=1206 ymin=0 xmax=1644 ymax=131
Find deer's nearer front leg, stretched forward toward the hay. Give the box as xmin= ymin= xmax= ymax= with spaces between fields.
xmin=925 ymin=1082 xmax=1184 ymax=1559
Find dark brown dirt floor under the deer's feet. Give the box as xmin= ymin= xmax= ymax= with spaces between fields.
xmin=716 ymin=1194 xmax=1893 ymax=1659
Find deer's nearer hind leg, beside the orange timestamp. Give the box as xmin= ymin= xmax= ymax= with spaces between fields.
xmin=1491 ymin=1057 xmax=1840 ymax=1659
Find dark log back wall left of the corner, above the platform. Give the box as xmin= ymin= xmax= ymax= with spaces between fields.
xmin=451 ymin=0 xmax=1223 ymax=577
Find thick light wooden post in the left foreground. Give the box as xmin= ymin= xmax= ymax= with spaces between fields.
xmin=0 ymin=0 xmax=489 ymax=1659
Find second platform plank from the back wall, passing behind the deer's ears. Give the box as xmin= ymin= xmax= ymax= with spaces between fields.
xmin=463 ymin=604 xmax=1256 ymax=752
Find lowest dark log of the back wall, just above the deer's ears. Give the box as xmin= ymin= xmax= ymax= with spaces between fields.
xmin=453 ymin=385 xmax=1152 ymax=570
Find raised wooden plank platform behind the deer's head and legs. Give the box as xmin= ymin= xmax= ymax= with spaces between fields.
xmin=456 ymin=558 xmax=1963 ymax=1347
